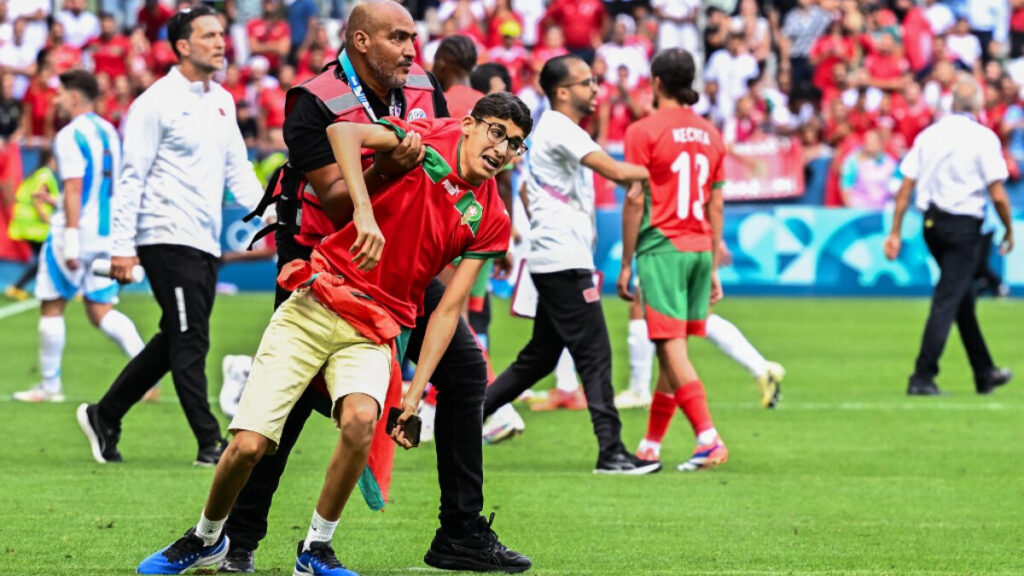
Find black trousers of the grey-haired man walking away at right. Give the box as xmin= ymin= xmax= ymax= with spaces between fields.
xmin=910 ymin=209 xmax=994 ymax=381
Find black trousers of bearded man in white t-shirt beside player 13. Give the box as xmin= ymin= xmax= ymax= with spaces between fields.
xmin=483 ymin=270 xmax=626 ymax=457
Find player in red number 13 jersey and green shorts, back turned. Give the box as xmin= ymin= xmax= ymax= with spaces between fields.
xmin=617 ymin=48 xmax=729 ymax=470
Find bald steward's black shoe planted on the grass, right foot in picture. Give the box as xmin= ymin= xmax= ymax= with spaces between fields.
xmin=423 ymin=513 xmax=534 ymax=574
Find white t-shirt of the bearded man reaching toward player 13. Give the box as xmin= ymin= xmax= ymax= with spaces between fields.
xmin=526 ymin=110 xmax=601 ymax=274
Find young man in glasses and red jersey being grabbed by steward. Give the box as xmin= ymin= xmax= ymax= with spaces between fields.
xmin=138 ymin=92 xmax=532 ymax=576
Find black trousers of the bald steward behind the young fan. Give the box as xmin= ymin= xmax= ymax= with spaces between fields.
xmin=224 ymin=234 xmax=487 ymax=550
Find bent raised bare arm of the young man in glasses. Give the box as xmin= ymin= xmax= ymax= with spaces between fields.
xmin=327 ymin=122 xmax=399 ymax=271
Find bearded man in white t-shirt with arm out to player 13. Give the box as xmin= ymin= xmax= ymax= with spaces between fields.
xmin=483 ymin=55 xmax=660 ymax=475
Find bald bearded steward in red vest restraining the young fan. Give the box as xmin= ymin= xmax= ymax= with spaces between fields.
xmin=219 ymin=0 xmax=530 ymax=572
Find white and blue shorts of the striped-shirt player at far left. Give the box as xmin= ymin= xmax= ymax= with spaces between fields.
xmin=36 ymin=236 xmax=119 ymax=304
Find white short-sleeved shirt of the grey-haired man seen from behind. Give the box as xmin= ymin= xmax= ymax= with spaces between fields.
xmin=899 ymin=114 xmax=1008 ymax=218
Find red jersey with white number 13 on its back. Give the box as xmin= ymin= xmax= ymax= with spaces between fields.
xmin=626 ymin=107 xmax=725 ymax=254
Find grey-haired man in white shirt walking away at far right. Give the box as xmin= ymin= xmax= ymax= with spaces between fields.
xmin=885 ymin=80 xmax=1014 ymax=396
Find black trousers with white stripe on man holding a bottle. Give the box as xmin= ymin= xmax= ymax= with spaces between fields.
xmin=98 ymin=244 xmax=221 ymax=448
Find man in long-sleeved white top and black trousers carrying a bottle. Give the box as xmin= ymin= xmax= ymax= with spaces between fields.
xmin=78 ymin=5 xmax=263 ymax=466
